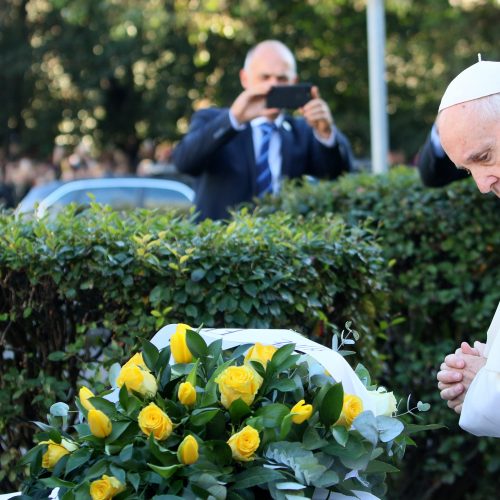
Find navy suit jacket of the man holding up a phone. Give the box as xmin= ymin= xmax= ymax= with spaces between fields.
xmin=173 ymin=108 xmax=352 ymax=219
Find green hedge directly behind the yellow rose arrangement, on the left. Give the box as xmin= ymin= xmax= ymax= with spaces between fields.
xmin=0 ymin=206 xmax=388 ymax=490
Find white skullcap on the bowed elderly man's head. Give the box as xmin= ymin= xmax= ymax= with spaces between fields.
xmin=439 ymin=61 xmax=500 ymax=111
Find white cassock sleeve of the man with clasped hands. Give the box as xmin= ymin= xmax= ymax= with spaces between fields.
xmin=459 ymin=304 xmax=500 ymax=437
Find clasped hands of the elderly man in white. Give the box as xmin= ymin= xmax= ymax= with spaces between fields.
xmin=437 ymin=342 xmax=486 ymax=413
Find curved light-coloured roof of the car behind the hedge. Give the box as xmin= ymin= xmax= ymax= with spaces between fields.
xmin=16 ymin=177 xmax=194 ymax=215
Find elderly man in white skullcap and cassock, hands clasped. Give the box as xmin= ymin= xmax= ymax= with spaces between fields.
xmin=437 ymin=61 xmax=500 ymax=437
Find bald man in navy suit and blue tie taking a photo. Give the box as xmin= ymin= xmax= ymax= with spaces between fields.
xmin=173 ymin=40 xmax=352 ymax=219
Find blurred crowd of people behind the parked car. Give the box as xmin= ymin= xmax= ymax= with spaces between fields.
xmin=0 ymin=139 xmax=178 ymax=208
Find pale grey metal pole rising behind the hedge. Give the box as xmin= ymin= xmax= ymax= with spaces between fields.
xmin=366 ymin=0 xmax=389 ymax=174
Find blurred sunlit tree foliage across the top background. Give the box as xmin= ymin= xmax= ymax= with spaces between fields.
xmin=0 ymin=0 xmax=500 ymax=162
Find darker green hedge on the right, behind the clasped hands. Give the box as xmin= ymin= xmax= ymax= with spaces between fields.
xmin=259 ymin=168 xmax=500 ymax=500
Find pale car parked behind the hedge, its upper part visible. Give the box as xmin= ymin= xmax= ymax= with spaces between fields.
xmin=16 ymin=177 xmax=194 ymax=217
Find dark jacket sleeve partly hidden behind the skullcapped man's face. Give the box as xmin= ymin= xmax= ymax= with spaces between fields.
xmin=417 ymin=134 xmax=468 ymax=187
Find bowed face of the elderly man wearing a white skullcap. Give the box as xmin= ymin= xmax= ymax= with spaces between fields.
xmin=438 ymin=102 xmax=500 ymax=197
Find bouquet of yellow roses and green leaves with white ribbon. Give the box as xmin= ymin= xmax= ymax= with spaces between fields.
xmin=23 ymin=324 xmax=432 ymax=500
